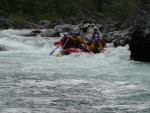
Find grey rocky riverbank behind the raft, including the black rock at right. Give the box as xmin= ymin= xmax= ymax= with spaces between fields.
xmin=0 ymin=4 xmax=150 ymax=62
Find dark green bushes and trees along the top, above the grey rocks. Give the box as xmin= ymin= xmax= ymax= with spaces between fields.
xmin=0 ymin=0 xmax=139 ymax=21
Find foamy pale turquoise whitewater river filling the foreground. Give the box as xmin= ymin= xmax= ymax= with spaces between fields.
xmin=0 ymin=29 xmax=150 ymax=113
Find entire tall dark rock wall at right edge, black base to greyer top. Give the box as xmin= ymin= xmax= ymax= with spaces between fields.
xmin=129 ymin=4 xmax=150 ymax=62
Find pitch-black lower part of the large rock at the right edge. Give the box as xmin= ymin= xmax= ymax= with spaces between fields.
xmin=129 ymin=25 xmax=150 ymax=62
